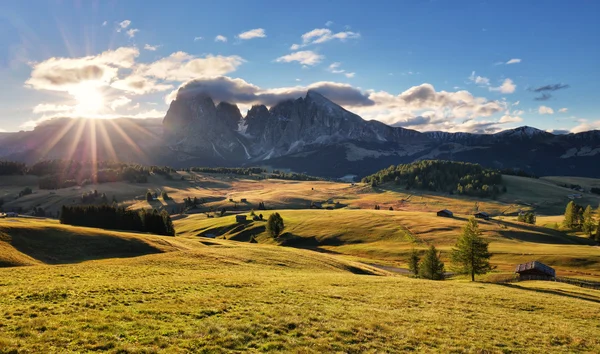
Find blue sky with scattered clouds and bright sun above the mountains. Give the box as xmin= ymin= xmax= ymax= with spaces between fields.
xmin=0 ymin=0 xmax=600 ymax=134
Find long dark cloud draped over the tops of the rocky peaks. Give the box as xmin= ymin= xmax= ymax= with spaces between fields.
xmin=171 ymin=76 xmax=375 ymax=106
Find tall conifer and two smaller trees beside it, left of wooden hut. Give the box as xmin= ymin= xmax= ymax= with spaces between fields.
xmin=408 ymin=218 xmax=494 ymax=281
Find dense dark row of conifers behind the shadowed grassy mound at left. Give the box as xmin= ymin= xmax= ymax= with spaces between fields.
xmin=60 ymin=205 xmax=175 ymax=236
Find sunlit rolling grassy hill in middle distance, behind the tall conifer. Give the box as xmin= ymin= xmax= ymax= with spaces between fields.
xmin=175 ymin=209 xmax=600 ymax=278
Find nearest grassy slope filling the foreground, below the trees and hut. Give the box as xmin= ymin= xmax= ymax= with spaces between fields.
xmin=0 ymin=240 xmax=600 ymax=353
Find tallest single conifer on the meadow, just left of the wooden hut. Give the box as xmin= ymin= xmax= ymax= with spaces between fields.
xmin=451 ymin=218 xmax=493 ymax=281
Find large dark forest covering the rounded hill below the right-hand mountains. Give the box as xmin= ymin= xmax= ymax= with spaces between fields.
xmin=362 ymin=160 xmax=506 ymax=197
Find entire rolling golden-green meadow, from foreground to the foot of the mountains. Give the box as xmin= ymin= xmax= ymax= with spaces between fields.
xmin=0 ymin=173 xmax=600 ymax=353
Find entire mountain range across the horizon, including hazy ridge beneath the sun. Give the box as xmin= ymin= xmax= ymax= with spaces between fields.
xmin=0 ymin=90 xmax=600 ymax=177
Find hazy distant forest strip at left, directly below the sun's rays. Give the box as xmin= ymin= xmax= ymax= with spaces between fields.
xmin=26 ymin=160 xmax=175 ymax=189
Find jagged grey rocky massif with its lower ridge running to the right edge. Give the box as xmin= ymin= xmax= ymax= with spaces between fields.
xmin=163 ymin=91 xmax=600 ymax=177
